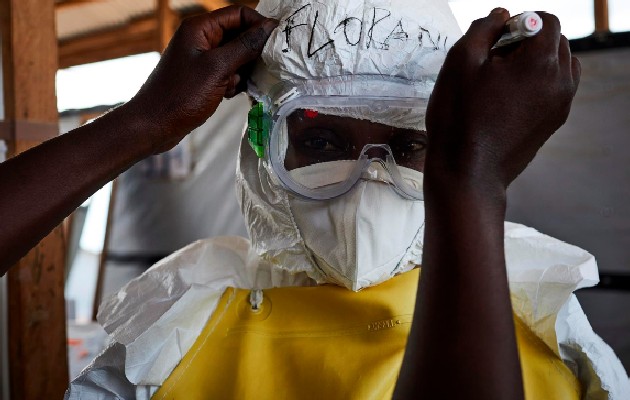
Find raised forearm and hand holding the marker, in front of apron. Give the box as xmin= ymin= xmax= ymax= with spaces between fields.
xmin=394 ymin=9 xmax=580 ymax=400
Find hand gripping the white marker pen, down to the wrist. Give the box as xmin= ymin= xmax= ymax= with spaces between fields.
xmin=425 ymin=9 xmax=580 ymax=189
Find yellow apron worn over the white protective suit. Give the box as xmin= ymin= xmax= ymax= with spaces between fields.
xmin=152 ymin=269 xmax=580 ymax=400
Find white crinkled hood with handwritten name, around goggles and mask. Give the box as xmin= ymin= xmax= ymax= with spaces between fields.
xmin=237 ymin=0 xmax=461 ymax=286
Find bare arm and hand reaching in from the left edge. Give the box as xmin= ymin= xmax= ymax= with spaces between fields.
xmin=0 ymin=6 xmax=277 ymax=275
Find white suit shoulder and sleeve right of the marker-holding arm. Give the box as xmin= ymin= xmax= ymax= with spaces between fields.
xmin=505 ymin=222 xmax=630 ymax=400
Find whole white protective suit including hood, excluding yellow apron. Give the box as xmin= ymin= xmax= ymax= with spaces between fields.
xmin=66 ymin=0 xmax=630 ymax=400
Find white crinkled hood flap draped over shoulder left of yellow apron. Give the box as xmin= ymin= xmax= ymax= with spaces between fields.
xmin=99 ymin=236 xmax=310 ymax=385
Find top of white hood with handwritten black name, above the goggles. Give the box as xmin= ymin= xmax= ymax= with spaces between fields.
xmin=249 ymin=0 xmax=461 ymax=153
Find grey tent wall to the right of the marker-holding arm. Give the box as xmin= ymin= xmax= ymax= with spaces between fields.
xmin=508 ymin=40 xmax=630 ymax=369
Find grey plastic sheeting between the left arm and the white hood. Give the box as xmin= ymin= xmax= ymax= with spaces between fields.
xmin=108 ymin=95 xmax=249 ymax=255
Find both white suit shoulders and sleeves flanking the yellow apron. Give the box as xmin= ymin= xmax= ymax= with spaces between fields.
xmin=66 ymin=223 xmax=630 ymax=400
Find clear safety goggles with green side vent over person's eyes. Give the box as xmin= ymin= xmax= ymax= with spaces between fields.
xmin=248 ymin=78 xmax=428 ymax=200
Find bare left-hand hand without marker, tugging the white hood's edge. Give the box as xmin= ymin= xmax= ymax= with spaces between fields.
xmin=127 ymin=6 xmax=278 ymax=153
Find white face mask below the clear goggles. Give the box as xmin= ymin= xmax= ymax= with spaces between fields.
xmin=289 ymin=180 xmax=424 ymax=291
